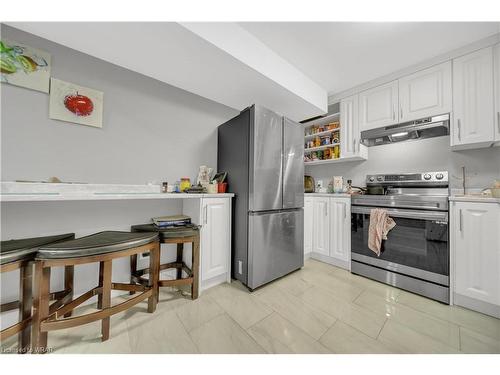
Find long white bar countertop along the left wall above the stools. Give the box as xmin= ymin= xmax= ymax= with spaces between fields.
xmin=0 ymin=182 xmax=234 ymax=202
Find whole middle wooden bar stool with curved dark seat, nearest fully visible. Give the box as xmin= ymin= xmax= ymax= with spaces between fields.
xmin=32 ymin=231 xmax=160 ymax=353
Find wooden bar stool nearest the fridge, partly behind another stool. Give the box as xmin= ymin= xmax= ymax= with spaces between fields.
xmin=130 ymin=224 xmax=200 ymax=299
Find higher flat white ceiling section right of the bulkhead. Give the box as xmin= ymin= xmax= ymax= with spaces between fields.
xmin=239 ymin=22 xmax=500 ymax=94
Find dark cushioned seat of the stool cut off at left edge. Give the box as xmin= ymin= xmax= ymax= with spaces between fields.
xmin=0 ymin=233 xmax=75 ymax=264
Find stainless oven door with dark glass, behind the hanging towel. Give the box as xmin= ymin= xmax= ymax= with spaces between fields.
xmin=351 ymin=206 xmax=450 ymax=286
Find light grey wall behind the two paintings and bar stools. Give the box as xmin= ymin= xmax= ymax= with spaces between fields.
xmin=1 ymin=25 xmax=237 ymax=328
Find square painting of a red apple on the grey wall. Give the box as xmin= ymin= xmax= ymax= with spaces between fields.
xmin=49 ymin=78 xmax=103 ymax=128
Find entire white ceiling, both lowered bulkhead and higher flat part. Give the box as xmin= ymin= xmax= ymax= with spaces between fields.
xmin=9 ymin=22 xmax=500 ymax=121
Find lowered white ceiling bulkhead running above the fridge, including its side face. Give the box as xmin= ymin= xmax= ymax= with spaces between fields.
xmin=9 ymin=22 xmax=328 ymax=121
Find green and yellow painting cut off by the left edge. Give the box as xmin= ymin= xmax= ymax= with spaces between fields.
xmin=0 ymin=39 xmax=51 ymax=93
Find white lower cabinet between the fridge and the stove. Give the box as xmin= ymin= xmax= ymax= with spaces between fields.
xmin=304 ymin=196 xmax=351 ymax=269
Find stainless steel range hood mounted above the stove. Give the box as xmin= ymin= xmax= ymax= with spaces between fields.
xmin=361 ymin=113 xmax=450 ymax=147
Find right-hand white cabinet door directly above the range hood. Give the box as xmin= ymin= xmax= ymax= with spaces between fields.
xmin=399 ymin=61 xmax=452 ymax=122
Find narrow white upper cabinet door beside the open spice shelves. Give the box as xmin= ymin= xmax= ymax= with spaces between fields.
xmin=340 ymin=95 xmax=361 ymax=158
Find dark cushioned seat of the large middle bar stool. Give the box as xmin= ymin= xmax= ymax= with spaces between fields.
xmin=36 ymin=231 xmax=158 ymax=259
